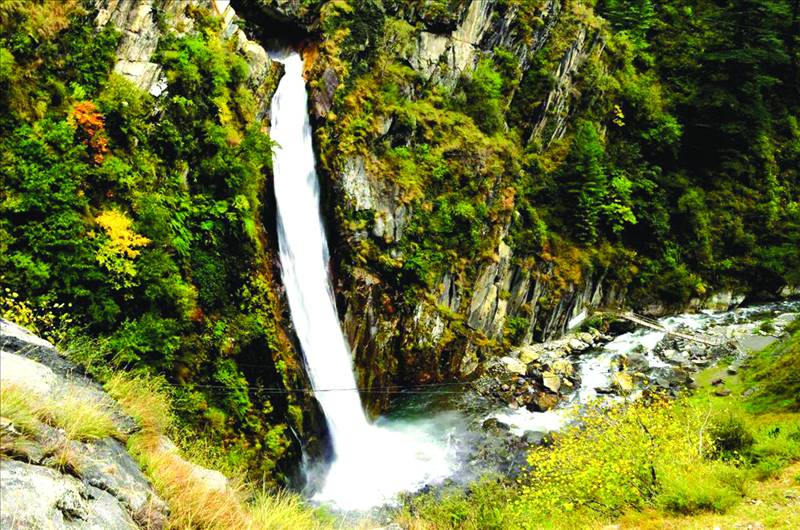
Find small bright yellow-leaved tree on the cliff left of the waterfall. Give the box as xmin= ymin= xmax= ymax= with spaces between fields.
xmin=95 ymin=210 xmax=150 ymax=289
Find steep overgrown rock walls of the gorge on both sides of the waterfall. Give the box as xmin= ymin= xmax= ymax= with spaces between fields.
xmin=0 ymin=0 xmax=800 ymax=492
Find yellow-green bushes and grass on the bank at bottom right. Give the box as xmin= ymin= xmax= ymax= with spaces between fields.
xmin=400 ymin=384 xmax=800 ymax=529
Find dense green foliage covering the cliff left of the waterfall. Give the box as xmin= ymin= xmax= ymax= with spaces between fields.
xmin=0 ymin=0 xmax=302 ymax=478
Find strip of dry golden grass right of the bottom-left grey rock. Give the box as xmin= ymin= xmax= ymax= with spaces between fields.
xmin=106 ymin=374 xmax=332 ymax=530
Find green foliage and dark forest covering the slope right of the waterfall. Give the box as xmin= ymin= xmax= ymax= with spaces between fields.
xmin=307 ymin=0 xmax=800 ymax=320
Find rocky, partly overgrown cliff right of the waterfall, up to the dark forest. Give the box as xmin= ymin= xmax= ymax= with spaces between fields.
xmin=234 ymin=0 xmax=780 ymax=410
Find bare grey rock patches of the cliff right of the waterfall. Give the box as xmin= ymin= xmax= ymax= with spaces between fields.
xmin=332 ymin=1 xmax=621 ymax=407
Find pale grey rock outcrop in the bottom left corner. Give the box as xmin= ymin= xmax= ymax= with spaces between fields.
xmin=0 ymin=320 xmax=168 ymax=530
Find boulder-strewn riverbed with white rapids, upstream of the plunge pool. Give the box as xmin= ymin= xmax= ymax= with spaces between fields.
xmin=476 ymin=301 xmax=800 ymax=440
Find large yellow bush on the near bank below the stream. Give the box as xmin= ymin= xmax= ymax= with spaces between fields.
xmin=516 ymin=395 xmax=733 ymax=517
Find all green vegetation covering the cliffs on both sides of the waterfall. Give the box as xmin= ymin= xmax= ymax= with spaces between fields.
xmin=0 ymin=0 xmax=800 ymax=496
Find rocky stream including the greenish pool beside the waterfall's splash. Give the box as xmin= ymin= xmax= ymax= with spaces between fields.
xmin=336 ymin=301 xmax=800 ymax=520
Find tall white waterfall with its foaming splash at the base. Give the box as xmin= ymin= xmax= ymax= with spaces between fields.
xmin=270 ymin=52 xmax=453 ymax=509
